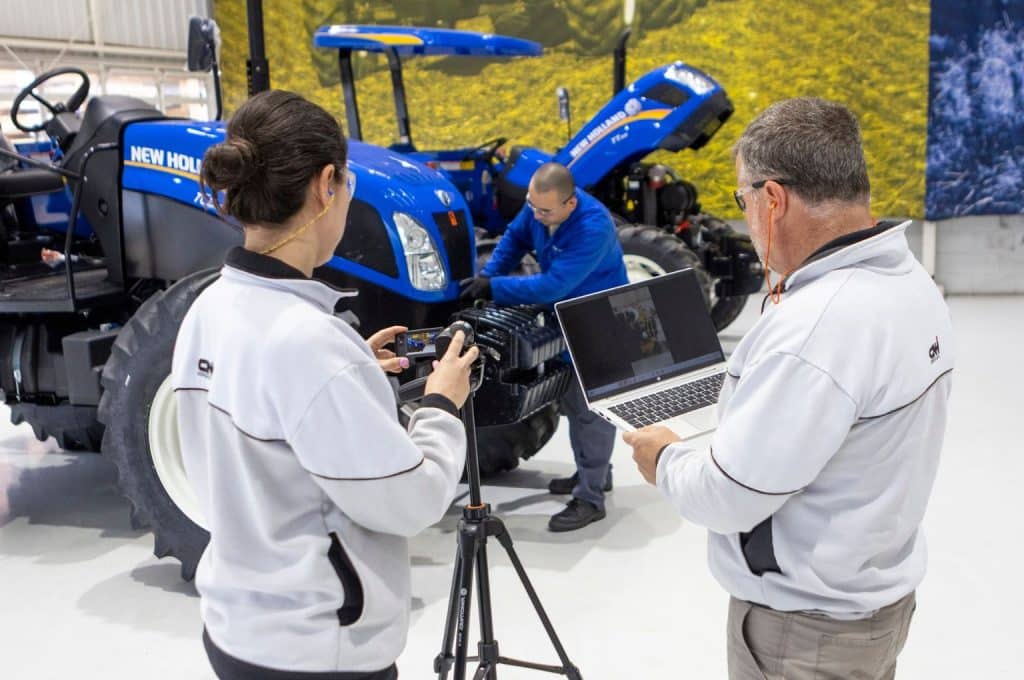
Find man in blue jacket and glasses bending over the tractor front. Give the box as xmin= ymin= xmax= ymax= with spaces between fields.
xmin=463 ymin=163 xmax=627 ymax=532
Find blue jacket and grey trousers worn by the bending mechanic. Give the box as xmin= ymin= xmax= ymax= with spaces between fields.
xmin=480 ymin=188 xmax=628 ymax=508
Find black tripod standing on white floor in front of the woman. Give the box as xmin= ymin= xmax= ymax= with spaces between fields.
xmin=434 ymin=394 xmax=583 ymax=680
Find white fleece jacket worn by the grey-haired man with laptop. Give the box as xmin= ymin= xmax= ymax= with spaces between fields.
xmin=656 ymin=222 xmax=954 ymax=618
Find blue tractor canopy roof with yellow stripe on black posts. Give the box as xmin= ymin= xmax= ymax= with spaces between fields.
xmin=313 ymin=25 xmax=544 ymax=56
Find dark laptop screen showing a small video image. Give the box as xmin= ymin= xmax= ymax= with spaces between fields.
xmin=555 ymin=269 xmax=725 ymax=401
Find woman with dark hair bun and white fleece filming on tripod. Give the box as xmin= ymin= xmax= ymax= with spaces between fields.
xmin=171 ymin=90 xmax=477 ymax=680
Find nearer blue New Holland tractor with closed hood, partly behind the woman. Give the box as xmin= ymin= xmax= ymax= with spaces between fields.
xmin=0 ymin=14 xmax=572 ymax=580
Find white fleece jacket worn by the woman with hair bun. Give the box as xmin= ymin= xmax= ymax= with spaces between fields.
xmin=172 ymin=251 xmax=466 ymax=671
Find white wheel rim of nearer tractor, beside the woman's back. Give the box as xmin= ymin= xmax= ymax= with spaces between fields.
xmin=150 ymin=376 xmax=206 ymax=527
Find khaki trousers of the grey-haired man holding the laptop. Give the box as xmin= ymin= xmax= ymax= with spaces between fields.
xmin=727 ymin=593 xmax=915 ymax=680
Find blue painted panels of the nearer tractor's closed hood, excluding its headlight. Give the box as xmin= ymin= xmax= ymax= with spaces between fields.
xmin=122 ymin=121 xmax=475 ymax=303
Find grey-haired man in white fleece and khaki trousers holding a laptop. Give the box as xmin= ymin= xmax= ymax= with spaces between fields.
xmin=625 ymin=98 xmax=953 ymax=680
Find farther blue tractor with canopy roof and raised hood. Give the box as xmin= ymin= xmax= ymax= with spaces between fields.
xmin=313 ymin=21 xmax=763 ymax=330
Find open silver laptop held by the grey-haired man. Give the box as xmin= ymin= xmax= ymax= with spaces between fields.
xmin=555 ymin=269 xmax=725 ymax=439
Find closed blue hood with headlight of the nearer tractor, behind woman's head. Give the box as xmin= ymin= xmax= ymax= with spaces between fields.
xmin=122 ymin=120 xmax=476 ymax=302
